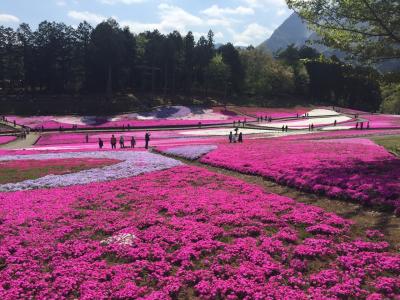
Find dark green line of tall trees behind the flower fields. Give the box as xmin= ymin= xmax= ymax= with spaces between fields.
xmin=0 ymin=19 xmax=386 ymax=110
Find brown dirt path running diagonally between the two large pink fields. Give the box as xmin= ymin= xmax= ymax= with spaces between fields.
xmin=155 ymin=151 xmax=400 ymax=251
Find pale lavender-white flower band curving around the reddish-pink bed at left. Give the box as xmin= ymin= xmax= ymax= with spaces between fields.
xmin=0 ymin=151 xmax=182 ymax=192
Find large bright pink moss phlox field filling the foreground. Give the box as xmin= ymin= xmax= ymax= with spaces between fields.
xmin=0 ymin=166 xmax=400 ymax=300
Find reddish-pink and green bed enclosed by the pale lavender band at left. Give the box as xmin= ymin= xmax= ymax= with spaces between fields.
xmin=0 ymin=158 xmax=119 ymax=184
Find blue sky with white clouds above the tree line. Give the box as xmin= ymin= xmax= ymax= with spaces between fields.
xmin=0 ymin=0 xmax=291 ymax=46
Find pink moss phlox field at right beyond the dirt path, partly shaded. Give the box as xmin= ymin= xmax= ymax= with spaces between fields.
xmin=200 ymin=139 xmax=400 ymax=213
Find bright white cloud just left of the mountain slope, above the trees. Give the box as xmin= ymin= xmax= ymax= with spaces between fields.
xmin=231 ymin=23 xmax=273 ymax=46
